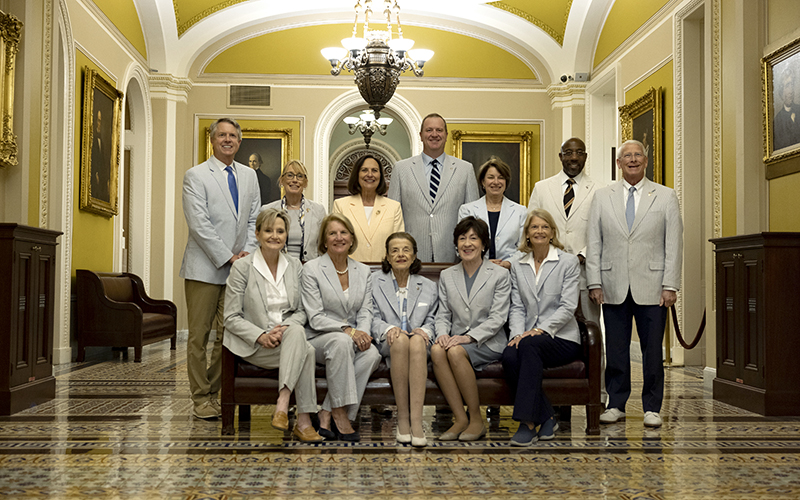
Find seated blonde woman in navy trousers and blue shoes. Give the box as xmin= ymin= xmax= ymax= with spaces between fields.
xmin=503 ymin=208 xmax=581 ymax=446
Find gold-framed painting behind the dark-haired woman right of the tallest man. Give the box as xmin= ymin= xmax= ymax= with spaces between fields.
xmin=452 ymin=130 xmax=533 ymax=205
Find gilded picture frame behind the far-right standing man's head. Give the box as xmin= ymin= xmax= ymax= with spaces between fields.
xmin=619 ymin=87 xmax=664 ymax=184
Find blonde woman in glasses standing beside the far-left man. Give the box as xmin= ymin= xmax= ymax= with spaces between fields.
xmin=261 ymin=160 xmax=327 ymax=263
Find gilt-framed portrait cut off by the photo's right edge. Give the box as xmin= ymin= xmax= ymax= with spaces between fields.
xmin=761 ymin=34 xmax=800 ymax=179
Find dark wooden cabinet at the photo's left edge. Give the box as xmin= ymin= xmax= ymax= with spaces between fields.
xmin=0 ymin=224 xmax=61 ymax=415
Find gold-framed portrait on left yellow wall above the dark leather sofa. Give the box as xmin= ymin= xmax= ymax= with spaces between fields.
xmin=80 ymin=66 xmax=122 ymax=217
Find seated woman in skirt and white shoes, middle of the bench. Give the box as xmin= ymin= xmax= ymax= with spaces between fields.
xmin=372 ymin=232 xmax=439 ymax=446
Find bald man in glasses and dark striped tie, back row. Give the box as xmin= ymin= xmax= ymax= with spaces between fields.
xmin=528 ymin=137 xmax=600 ymax=325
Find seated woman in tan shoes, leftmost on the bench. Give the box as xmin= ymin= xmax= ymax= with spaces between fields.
xmin=222 ymin=209 xmax=322 ymax=441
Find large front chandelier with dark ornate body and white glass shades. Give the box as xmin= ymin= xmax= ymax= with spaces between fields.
xmin=322 ymin=0 xmax=433 ymax=118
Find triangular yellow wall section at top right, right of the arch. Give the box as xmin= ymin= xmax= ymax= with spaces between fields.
xmin=594 ymin=0 xmax=669 ymax=67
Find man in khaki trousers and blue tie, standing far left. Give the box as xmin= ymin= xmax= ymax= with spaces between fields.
xmin=180 ymin=118 xmax=261 ymax=419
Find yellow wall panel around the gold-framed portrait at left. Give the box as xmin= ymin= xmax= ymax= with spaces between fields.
xmin=72 ymin=51 xmax=114 ymax=278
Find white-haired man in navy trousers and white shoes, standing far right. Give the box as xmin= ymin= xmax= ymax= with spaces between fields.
xmin=586 ymin=141 xmax=683 ymax=427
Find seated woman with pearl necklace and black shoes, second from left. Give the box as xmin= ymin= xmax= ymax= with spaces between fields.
xmin=302 ymin=214 xmax=381 ymax=441
